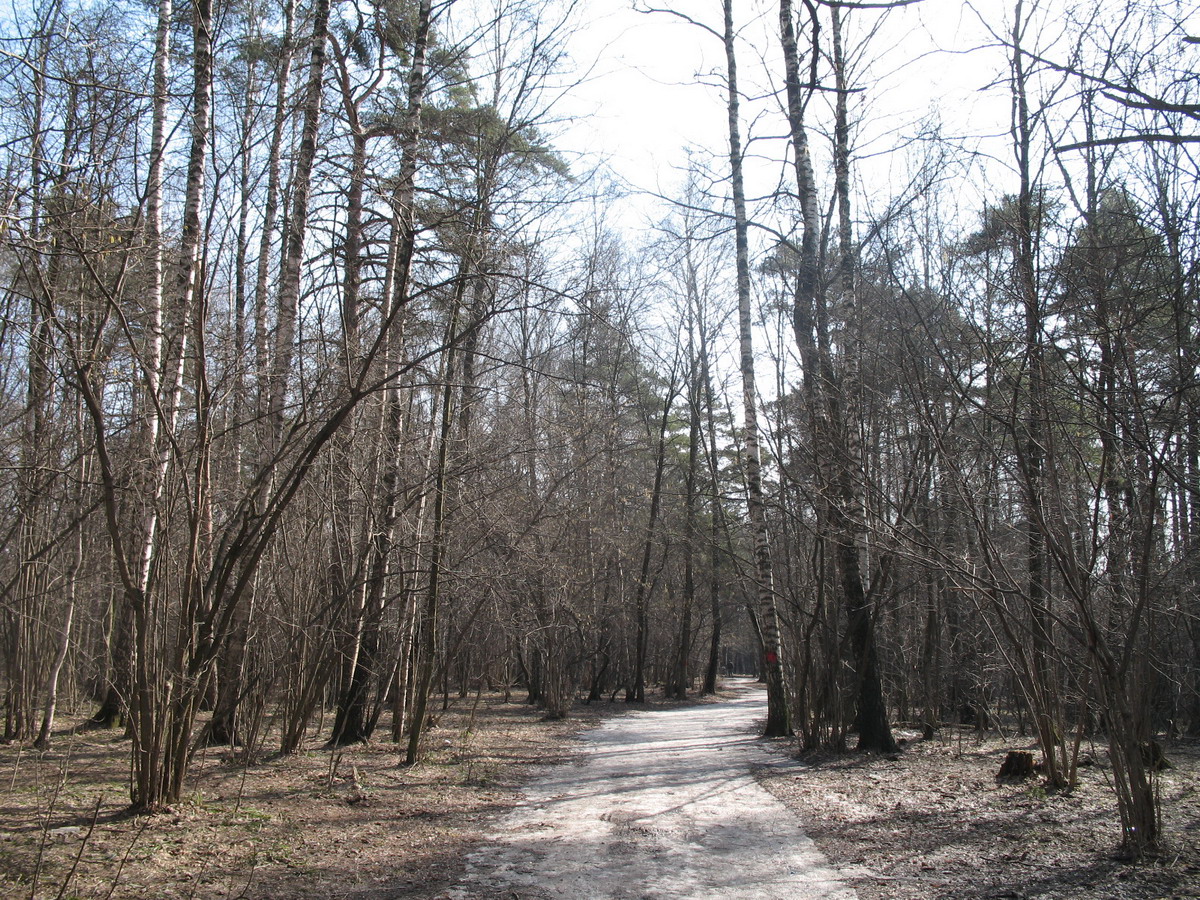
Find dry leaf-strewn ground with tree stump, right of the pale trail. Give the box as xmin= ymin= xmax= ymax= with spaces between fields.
xmin=758 ymin=730 xmax=1200 ymax=900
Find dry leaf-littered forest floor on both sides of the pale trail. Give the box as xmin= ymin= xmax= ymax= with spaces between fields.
xmin=0 ymin=695 xmax=1200 ymax=900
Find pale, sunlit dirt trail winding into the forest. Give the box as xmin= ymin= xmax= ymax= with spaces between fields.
xmin=449 ymin=679 xmax=856 ymax=900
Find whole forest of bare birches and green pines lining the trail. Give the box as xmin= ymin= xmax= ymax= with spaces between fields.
xmin=0 ymin=0 xmax=1200 ymax=868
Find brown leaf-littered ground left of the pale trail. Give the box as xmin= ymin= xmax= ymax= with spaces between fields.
xmin=0 ymin=695 xmax=623 ymax=900
